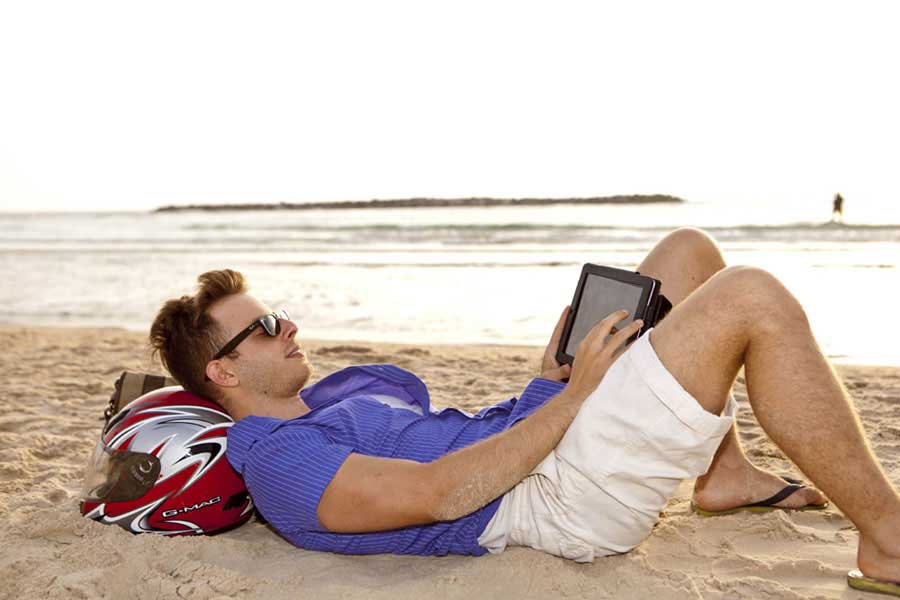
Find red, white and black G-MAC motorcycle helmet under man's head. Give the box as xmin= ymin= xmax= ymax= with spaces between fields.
xmin=81 ymin=386 xmax=253 ymax=535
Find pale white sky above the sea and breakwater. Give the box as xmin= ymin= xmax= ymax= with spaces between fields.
xmin=0 ymin=0 xmax=900 ymax=211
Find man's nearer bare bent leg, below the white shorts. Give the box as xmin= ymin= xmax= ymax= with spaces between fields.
xmin=650 ymin=267 xmax=900 ymax=582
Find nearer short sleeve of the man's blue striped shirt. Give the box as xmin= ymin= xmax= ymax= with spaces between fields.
xmin=244 ymin=428 xmax=353 ymax=533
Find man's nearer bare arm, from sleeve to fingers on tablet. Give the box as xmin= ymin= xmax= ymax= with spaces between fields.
xmin=317 ymin=311 xmax=643 ymax=533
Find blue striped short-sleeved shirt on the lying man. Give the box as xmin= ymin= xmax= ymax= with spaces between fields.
xmin=226 ymin=365 xmax=565 ymax=556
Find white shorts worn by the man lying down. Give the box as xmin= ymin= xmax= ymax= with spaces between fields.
xmin=478 ymin=329 xmax=737 ymax=562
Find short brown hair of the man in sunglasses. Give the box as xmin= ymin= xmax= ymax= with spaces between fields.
xmin=150 ymin=269 xmax=247 ymax=402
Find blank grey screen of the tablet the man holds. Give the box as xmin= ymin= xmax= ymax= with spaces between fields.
xmin=566 ymin=273 xmax=644 ymax=356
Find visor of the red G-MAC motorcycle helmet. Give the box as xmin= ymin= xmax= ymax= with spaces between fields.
xmin=81 ymin=441 xmax=161 ymax=502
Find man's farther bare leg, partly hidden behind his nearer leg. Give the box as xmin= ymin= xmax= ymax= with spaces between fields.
xmin=637 ymin=228 xmax=825 ymax=511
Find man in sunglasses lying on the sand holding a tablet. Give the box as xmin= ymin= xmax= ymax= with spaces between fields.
xmin=150 ymin=229 xmax=900 ymax=596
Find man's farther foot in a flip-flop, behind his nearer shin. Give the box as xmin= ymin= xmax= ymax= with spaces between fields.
xmin=691 ymin=463 xmax=827 ymax=513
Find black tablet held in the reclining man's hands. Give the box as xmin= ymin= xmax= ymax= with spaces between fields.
xmin=556 ymin=263 xmax=662 ymax=365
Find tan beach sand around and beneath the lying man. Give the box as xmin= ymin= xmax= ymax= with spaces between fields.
xmin=0 ymin=326 xmax=900 ymax=600
